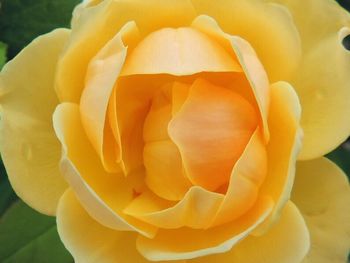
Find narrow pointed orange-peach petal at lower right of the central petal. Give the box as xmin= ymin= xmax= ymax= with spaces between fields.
xmin=213 ymin=130 xmax=267 ymax=225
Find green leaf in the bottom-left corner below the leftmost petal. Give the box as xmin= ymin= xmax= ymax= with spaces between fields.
xmin=0 ymin=201 xmax=74 ymax=263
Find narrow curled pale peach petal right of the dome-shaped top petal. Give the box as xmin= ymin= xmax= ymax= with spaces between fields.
xmin=192 ymin=15 xmax=270 ymax=141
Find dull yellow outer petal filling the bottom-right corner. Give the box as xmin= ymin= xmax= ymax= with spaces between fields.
xmin=292 ymin=158 xmax=350 ymax=263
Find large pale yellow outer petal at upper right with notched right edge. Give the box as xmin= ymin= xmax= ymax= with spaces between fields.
xmin=268 ymin=0 xmax=350 ymax=160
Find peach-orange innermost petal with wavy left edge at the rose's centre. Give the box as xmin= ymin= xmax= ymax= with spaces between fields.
xmin=168 ymin=79 xmax=258 ymax=191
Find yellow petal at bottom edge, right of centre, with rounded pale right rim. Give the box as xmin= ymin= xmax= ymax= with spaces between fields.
xmin=188 ymin=202 xmax=308 ymax=263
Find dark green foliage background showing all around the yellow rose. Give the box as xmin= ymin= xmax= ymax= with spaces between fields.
xmin=0 ymin=0 xmax=350 ymax=263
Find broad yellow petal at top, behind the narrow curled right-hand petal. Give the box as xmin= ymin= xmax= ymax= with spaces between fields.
xmin=191 ymin=0 xmax=301 ymax=82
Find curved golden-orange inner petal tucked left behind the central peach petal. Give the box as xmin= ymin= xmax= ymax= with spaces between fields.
xmin=143 ymin=82 xmax=191 ymax=200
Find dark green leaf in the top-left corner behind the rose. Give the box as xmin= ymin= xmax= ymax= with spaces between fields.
xmin=0 ymin=0 xmax=81 ymax=59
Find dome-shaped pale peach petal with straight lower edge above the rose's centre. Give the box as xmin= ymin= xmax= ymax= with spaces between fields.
xmin=122 ymin=27 xmax=241 ymax=76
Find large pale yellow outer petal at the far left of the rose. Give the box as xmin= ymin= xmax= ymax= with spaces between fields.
xmin=0 ymin=29 xmax=70 ymax=215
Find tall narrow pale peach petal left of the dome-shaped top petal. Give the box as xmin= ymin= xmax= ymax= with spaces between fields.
xmin=80 ymin=22 xmax=137 ymax=172
